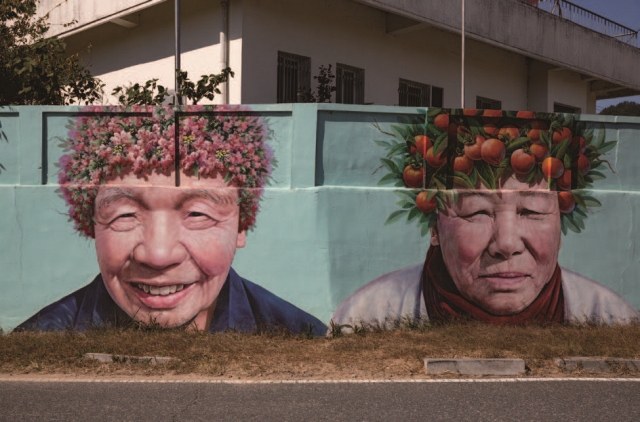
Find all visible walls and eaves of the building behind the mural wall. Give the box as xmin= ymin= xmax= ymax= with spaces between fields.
xmin=58 ymin=0 xmax=595 ymax=112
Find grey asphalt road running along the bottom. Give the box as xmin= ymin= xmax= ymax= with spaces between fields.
xmin=0 ymin=381 xmax=640 ymax=421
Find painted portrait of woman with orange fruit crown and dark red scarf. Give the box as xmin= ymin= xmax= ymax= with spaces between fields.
xmin=332 ymin=109 xmax=638 ymax=325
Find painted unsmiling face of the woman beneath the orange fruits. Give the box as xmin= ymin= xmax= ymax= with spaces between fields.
xmin=431 ymin=176 xmax=561 ymax=315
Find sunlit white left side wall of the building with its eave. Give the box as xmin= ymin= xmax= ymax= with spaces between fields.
xmin=66 ymin=0 xmax=242 ymax=104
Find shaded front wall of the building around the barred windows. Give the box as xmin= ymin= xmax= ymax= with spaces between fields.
xmin=243 ymin=0 xmax=527 ymax=109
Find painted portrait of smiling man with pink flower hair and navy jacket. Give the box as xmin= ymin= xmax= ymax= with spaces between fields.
xmin=18 ymin=107 xmax=326 ymax=335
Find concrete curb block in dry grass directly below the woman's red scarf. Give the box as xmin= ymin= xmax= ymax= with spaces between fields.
xmin=424 ymin=358 xmax=525 ymax=376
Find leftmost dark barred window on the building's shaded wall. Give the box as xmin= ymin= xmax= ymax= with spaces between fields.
xmin=277 ymin=51 xmax=311 ymax=103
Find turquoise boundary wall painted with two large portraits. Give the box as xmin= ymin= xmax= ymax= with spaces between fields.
xmin=0 ymin=104 xmax=640 ymax=335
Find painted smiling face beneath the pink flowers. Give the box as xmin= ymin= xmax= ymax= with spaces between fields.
xmin=95 ymin=173 xmax=245 ymax=330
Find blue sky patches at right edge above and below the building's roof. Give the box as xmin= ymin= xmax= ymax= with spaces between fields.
xmin=556 ymin=0 xmax=640 ymax=112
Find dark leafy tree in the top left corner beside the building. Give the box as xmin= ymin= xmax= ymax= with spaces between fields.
xmin=0 ymin=0 xmax=104 ymax=105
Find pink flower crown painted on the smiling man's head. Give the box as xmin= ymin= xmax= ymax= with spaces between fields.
xmin=58 ymin=106 xmax=272 ymax=237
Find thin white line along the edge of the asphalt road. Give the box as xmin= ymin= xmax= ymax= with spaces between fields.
xmin=0 ymin=376 xmax=640 ymax=384
